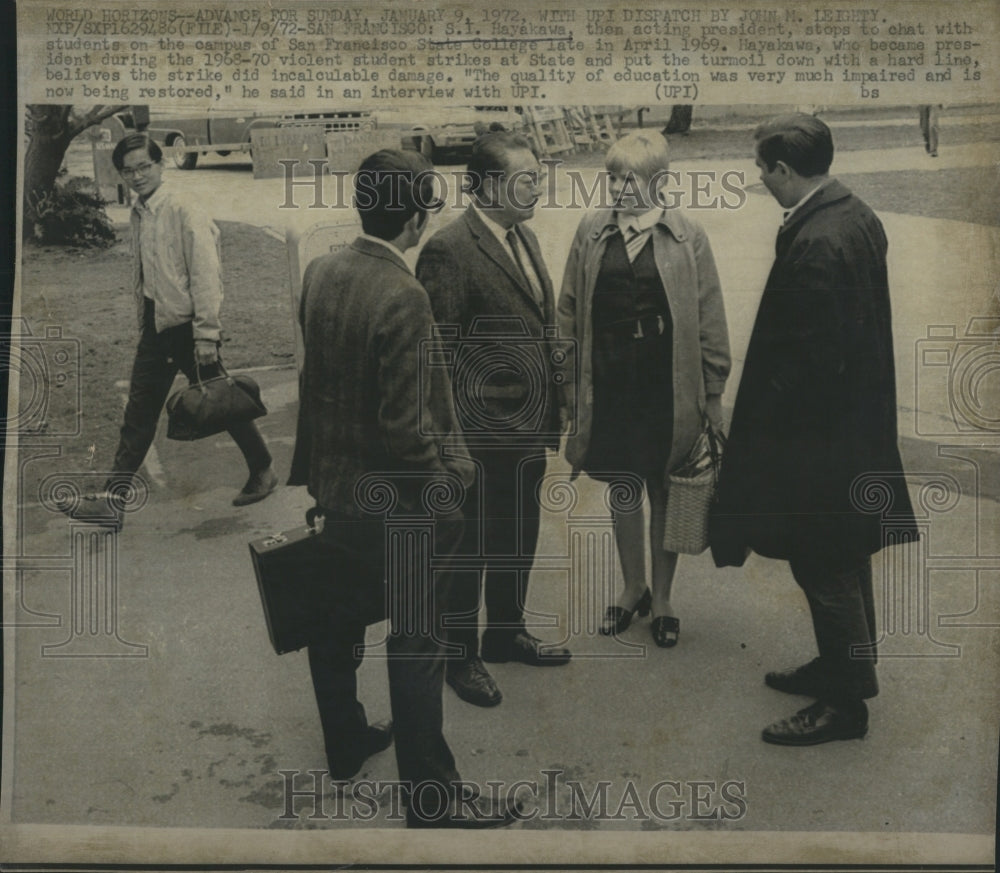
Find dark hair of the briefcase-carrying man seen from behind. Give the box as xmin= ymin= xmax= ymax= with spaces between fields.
xmin=354 ymin=149 xmax=443 ymax=240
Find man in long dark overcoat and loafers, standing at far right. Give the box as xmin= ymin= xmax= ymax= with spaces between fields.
xmin=711 ymin=114 xmax=916 ymax=745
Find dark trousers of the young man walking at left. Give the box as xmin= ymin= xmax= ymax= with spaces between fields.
xmin=112 ymin=298 xmax=271 ymax=474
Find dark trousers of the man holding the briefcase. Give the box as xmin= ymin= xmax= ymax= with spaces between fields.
xmin=309 ymin=513 xmax=462 ymax=797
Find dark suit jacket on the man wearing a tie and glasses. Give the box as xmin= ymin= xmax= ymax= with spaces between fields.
xmin=417 ymin=205 xmax=562 ymax=449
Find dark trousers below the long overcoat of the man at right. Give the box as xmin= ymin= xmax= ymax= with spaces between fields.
xmin=789 ymin=556 xmax=878 ymax=705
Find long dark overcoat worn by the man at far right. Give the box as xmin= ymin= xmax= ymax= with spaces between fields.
xmin=713 ymin=180 xmax=915 ymax=562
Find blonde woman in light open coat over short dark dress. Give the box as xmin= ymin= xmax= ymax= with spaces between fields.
xmin=558 ymin=131 xmax=730 ymax=648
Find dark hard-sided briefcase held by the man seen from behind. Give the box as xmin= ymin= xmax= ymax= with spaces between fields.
xmin=249 ymin=509 xmax=385 ymax=655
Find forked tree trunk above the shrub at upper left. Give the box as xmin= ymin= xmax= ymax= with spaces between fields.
xmin=22 ymin=103 xmax=126 ymax=234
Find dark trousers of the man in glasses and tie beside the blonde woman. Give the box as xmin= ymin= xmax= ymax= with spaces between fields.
xmin=444 ymin=446 xmax=546 ymax=658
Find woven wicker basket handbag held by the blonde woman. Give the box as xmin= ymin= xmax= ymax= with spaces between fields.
xmin=663 ymin=421 xmax=726 ymax=555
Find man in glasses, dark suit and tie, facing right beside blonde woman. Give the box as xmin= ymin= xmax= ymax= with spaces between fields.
xmin=417 ymin=131 xmax=570 ymax=706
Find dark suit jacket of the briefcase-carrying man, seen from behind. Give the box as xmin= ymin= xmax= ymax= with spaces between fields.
xmin=288 ymin=237 xmax=473 ymax=516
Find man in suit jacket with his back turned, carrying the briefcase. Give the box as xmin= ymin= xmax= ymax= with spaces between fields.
xmin=289 ymin=150 xmax=517 ymax=827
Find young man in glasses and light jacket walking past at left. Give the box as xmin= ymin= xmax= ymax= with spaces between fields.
xmin=67 ymin=133 xmax=278 ymax=528
